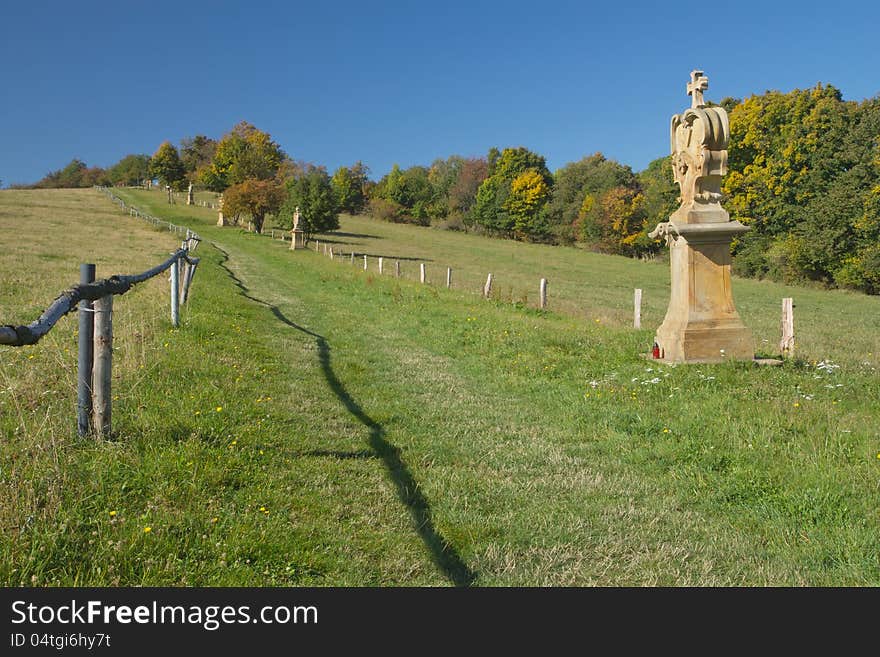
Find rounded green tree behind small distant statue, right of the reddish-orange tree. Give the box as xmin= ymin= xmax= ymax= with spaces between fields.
xmin=278 ymin=167 xmax=339 ymax=239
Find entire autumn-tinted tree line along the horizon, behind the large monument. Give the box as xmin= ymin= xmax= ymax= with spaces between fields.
xmin=20 ymin=84 xmax=880 ymax=294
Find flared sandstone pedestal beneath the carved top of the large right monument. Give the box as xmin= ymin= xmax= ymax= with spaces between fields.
xmin=655 ymin=221 xmax=755 ymax=363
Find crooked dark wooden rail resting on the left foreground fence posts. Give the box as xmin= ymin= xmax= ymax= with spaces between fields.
xmin=0 ymin=249 xmax=199 ymax=347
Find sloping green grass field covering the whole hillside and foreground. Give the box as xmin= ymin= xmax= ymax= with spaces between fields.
xmin=0 ymin=190 xmax=880 ymax=586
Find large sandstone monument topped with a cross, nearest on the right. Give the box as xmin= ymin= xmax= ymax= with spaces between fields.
xmin=650 ymin=71 xmax=755 ymax=363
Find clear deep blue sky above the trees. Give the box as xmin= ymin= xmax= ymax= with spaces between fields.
xmin=0 ymin=0 xmax=880 ymax=186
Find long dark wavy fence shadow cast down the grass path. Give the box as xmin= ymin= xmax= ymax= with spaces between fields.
xmin=213 ymin=244 xmax=477 ymax=586
